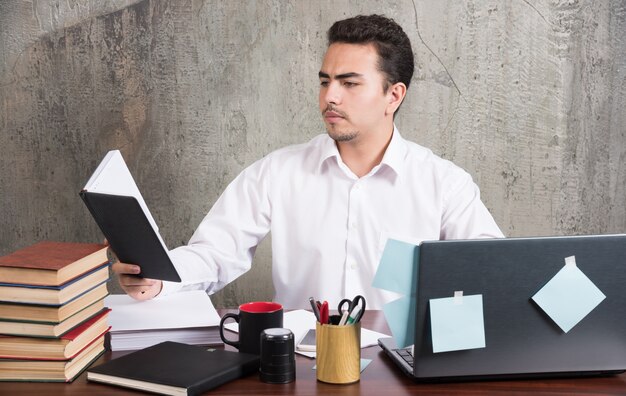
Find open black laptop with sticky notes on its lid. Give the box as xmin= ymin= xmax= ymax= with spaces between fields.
xmin=378 ymin=235 xmax=626 ymax=382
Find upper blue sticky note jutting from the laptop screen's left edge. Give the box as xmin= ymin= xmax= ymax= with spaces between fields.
xmin=372 ymin=239 xmax=419 ymax=295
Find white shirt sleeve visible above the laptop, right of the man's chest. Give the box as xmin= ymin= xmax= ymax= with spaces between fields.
xmin=440 ymin=168 xmax=504 ymax=239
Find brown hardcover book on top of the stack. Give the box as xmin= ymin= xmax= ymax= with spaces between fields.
xmin=0 ymin=241 xmax=109 ymax=286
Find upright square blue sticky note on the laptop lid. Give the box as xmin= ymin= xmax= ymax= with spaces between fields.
xmin=430 ymin=294 xmax=485 ymax=353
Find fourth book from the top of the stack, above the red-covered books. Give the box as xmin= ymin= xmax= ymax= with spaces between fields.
xmin=0 ymin=302 xmax=103 ymax=338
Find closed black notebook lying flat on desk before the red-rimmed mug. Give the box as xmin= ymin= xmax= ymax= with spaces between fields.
xmin=87 ymin=341 xmax=259 ymax=395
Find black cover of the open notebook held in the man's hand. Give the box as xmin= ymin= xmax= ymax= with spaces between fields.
xmin=79 ymin=191 xmax=180 ymax=282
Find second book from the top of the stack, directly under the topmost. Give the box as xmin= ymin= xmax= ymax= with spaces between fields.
xmin=0 ymin=263 xmax=109 ymax=306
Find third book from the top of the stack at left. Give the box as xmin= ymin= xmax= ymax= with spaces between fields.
xmin=0 ymin=283 xmax=109 ymax=323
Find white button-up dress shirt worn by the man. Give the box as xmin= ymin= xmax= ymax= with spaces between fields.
xmin=162 ymin=128 xmax=503 ymax=309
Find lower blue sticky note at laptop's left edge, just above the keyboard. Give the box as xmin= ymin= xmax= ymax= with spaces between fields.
xmin=383 ymin=296 xmax=416 ymax=348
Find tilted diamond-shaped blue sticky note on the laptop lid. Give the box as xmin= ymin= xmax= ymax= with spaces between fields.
xmin=532 ymin=256 xmax=606 ymax=333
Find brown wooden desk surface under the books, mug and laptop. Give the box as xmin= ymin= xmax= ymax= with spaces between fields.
xmin=0 ymin=310 xmax=626 ymax=396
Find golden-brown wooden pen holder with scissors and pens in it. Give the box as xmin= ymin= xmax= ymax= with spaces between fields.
xmin=315 ymin=322 xmax=361 ymax=384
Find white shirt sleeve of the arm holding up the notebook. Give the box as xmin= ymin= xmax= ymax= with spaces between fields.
xmin=160 ymin=157 xmax=271 ymax=295
